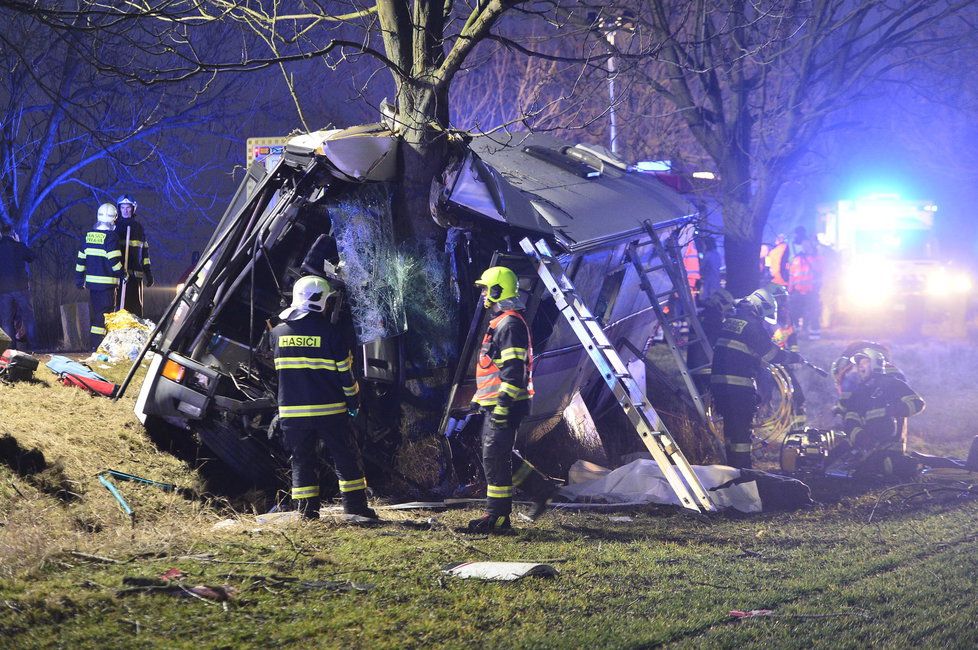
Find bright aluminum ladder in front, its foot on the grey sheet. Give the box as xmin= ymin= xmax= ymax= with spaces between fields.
xmin=520 ymin=238 xmax=716 ymax=512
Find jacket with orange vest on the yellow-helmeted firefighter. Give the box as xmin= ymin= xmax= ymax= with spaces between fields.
xmin=472 ymin=309 xmax=533 ymax=416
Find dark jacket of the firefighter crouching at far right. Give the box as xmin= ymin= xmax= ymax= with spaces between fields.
xmin=843 ymin=373 xmax=924 ymax=448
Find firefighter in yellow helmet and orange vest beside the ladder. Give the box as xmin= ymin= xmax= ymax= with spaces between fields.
xmin=466 ymin=266 xmax=557 ymax=534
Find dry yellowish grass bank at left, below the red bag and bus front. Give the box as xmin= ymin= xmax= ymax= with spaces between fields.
xmin=0 ymin=356 xmax=218 ymax=577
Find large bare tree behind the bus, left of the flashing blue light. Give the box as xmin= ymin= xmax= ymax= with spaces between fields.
xmin=602 ymin=0 xmax=973 ymax=294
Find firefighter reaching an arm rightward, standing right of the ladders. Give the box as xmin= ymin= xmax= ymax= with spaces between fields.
xmin=710 ymin=289 xmax=802 ymax=469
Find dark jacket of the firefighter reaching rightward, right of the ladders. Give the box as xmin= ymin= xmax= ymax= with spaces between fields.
xmin=710 ymin=304 xmax=799 ymax=389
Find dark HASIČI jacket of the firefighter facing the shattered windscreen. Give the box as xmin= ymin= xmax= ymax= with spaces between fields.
xmin=269 ymin=313 xmax=360 ymax=429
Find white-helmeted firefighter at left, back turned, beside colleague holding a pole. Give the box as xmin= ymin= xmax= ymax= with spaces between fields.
xmin=75 ymin=203 xmax=122 ymax=350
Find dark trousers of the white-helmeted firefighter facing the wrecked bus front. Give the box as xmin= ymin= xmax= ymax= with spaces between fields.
xmin=282 ymin=414 xmax=367 ymax=517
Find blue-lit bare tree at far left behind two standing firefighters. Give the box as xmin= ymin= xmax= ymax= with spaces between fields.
xmin=0 ymin=16 xmax=252 ymax=243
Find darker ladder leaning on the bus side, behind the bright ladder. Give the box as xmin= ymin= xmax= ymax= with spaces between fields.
xmin=627 ymin=221 xmax=713 ymax=422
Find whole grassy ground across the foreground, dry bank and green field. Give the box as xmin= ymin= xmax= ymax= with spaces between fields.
xmin=0 ymin=341 xmax=978 ymax=648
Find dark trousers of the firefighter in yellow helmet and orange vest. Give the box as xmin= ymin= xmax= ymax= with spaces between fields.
xmin=481 ymin=403 xmax=556 ymax=517
